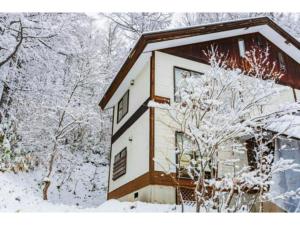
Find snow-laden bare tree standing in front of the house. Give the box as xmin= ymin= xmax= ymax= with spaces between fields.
xmin=149 ymin=47 xmax=300 ymax=212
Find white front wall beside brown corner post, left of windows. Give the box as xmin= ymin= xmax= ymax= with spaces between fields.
xmin=154 ymin=52 xmax=209 ymax=172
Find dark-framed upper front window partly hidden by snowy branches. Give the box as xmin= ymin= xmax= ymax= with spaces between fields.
xmin=174 ymin=67 xmax=203 ymax=102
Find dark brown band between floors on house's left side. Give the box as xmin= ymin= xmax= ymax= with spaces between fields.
xmin=111 ymin=98 xmax=149 ymax=144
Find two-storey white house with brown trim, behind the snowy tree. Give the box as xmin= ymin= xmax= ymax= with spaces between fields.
xmin=100 ymin=17 xmax=300 ymax=210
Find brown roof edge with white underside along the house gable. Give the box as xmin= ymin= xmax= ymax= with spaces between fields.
xmin=99 ymin=16 xmax=300 ymax=109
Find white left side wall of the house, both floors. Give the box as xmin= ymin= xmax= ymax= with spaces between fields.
xmin=109 ymin=63 xmax=150 ymax=192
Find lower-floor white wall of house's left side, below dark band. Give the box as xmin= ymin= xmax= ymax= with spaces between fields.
xmin=109 ymin=110 xmax=149 ymax=192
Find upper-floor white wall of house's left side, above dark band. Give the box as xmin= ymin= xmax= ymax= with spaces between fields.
xmin=113 ymin=62 xmax=150 ymax=134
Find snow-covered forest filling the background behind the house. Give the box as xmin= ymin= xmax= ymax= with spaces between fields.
xmin=0 ymin=13 xmax=300 ymax=207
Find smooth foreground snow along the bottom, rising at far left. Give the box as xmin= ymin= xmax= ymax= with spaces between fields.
xmin=0 ymin=173 xmax=194 ymax=212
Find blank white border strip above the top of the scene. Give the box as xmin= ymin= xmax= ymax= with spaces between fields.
xmin=0 ymin=0 xmax=300 ymax=12
